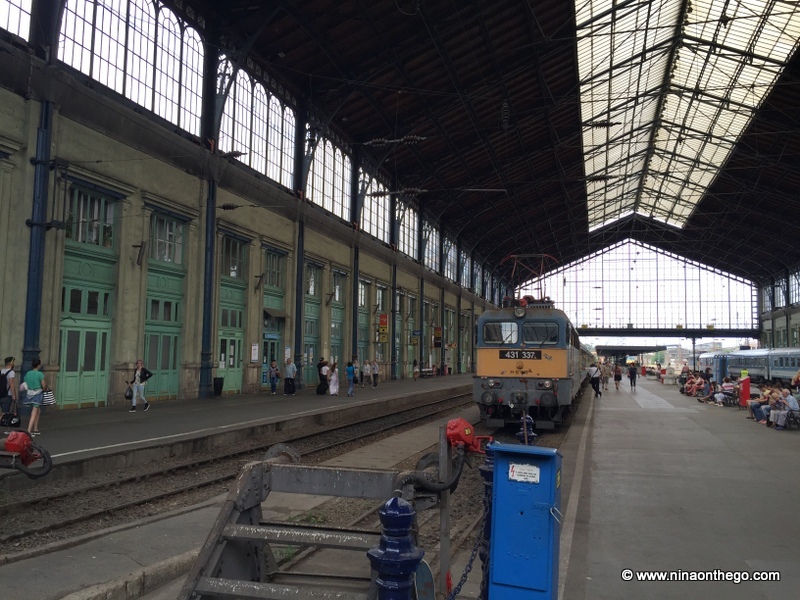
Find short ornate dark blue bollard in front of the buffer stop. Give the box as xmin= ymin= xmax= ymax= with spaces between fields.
xmin=367 ymin=497 xmax=425 ymax=600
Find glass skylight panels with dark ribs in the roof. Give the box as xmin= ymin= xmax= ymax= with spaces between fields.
xmin=575 ymin=0 xmax=800 ymax=231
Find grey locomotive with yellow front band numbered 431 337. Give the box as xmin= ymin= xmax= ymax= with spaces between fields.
xmin=473 ymin=296 xmax=594 ymax=429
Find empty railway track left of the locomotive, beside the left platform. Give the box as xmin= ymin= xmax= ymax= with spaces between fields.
xmin=0 ymin=394 xmax=471 ymax=562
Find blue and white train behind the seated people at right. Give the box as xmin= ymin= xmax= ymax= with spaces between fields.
xmin=697 ymin=348 xmax=800 ymax=385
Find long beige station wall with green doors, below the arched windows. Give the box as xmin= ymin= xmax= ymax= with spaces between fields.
xmin=0 ymin=45 xmax=486 ymax=408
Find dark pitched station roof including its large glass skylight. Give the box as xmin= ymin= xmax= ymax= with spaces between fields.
xmin=165 ymin=0 xmax=800 ymax=285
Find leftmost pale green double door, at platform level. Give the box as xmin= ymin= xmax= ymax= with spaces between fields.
xmin=56 ymin=323 xmax=111 ymax=408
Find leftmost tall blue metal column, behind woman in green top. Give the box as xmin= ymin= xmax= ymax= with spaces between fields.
xmin=22 ymin=100 xmax=53 ymax=373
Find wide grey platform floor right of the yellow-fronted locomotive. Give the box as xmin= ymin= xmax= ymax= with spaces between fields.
xmin=560 ymin=378 xmax=800 ymax=600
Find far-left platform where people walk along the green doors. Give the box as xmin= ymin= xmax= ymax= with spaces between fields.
xmin=0 ymin=374 xmax=472 ymax=492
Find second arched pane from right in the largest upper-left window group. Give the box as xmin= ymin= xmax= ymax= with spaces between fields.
xmin=153 ymin=8 xmax=182 ymax=123
